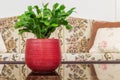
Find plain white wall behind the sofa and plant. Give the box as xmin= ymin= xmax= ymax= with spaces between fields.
xmin=0 ymin=0 xmax=120 ymax=21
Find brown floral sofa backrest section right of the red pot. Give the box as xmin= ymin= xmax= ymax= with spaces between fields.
xmin=51 ymin=17 xmax=92 ymax=53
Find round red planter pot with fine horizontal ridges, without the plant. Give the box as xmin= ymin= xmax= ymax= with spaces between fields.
xmin=25 ymin=39 xmax=61 ymax=72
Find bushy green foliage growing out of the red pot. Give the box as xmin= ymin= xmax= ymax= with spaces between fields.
xmin=14 ymin=3 xmax=75 ymax=38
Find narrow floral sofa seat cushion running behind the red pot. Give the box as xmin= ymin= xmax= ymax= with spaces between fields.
xmin=0 ymin=53 xmax=120 ymax=61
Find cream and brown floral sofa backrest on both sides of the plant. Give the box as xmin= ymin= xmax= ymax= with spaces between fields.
xmin=0 ymin=16 xmax=92 ymax=53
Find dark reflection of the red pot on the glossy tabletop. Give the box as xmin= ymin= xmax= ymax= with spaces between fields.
xmin=26 ymin=72 xmax=61 ymax=80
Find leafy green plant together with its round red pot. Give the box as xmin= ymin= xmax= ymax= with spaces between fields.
xmin=14 ymin=3 xmax=75 ymax=72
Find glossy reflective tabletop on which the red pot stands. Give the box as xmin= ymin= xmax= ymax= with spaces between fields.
xmin=0 ymin=60 xmax=120 ymax=80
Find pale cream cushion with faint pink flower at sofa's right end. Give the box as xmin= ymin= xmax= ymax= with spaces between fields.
xmin=90 ymin=28 xmax=120 ymax=53
